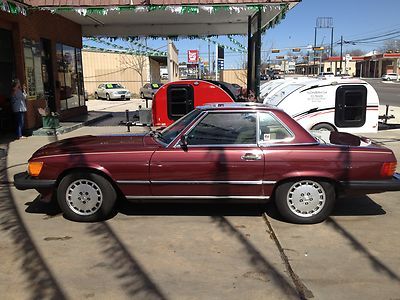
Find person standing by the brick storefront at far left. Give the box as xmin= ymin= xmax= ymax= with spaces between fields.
xmin=11 ymin=79 xmax=26 ymax=139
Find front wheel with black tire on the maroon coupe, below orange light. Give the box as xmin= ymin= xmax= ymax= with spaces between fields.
xmin=57 ymin=171 xmax=117 ymax=222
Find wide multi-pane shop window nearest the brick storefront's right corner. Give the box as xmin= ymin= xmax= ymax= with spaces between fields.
xmin=56 ymin=44 xmax=85 ymax=110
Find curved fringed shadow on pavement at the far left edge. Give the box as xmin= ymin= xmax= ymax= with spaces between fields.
xmin=0 ymin=144 xmax=66 ymax=299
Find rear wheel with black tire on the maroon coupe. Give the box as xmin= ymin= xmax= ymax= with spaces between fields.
xmin=275 ymin=179 xmax=336 ymax=224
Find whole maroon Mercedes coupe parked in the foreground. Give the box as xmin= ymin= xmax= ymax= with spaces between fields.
xmin=14 ymin=103 xmax=400 ymax=223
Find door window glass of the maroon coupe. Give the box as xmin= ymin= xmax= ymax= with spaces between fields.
xmin=187 ymin=112 xmax=257 ymax=146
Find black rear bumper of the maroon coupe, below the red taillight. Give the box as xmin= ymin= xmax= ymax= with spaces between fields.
xmin=340 ymin=173 xmax=400 ymax=195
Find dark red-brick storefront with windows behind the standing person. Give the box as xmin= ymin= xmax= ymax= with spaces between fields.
xmin=0 ymin=6 xmax=87 ymax=132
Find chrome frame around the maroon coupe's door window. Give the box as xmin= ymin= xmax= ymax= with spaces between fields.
xmin=172 ymin=109 xmax=259 ymax=148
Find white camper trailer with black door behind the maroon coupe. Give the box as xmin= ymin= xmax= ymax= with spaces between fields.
xmin=264 ymin=77 xmax=379 ymax=133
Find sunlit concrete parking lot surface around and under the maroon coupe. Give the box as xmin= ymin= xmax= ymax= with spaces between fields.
xmin=0 ymin=100 xmax=400 ymax=300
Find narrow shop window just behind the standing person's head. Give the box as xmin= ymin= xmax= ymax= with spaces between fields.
xmin=23 ymin=39 xmax=44 ymax=99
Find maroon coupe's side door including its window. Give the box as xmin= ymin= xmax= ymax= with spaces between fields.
xmin=150 ymin=112 xmax=264 ymax=198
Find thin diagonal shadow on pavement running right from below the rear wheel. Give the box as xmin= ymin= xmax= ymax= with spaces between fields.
xmin=326 ymin=218 xmax=400 ymax=283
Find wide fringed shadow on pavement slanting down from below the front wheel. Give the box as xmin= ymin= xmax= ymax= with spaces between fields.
xmin=88 ymin=222 xmax=167 ymax=299
